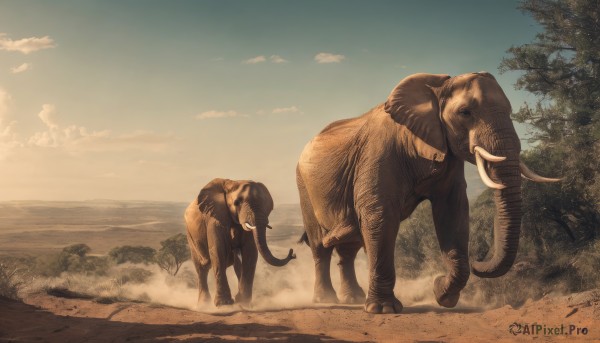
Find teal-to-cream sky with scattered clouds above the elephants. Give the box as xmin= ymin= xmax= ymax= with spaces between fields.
xmin=0 ymin=0 xmax=539 ymax=203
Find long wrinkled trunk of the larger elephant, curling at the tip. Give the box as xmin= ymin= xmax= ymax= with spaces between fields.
xmin=471 ymin=134 xmax=522 ymax=278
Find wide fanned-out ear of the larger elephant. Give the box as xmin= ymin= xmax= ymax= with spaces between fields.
xmin=384 ymin=74 xmax=450 ymax=162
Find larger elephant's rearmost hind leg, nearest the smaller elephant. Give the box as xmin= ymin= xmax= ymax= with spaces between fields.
xmin=297 ymin=174 xmax=337 ymax=303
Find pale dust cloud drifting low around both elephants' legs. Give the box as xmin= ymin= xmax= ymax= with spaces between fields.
xmin=23 ymin=237 xmax=490 ymax=313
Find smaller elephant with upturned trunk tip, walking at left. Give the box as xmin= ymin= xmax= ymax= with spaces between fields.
xmin=184 ymin=179 xmax=296 ymax=306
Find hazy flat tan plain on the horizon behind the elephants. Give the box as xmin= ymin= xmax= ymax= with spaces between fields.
xmin=0 ymin=171 xmax=485 ymax=254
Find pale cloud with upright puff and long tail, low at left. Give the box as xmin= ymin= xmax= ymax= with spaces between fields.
xmin=28 ymin=104 xmax=173 ymax=153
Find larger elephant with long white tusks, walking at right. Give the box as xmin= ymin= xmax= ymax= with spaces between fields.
xmin=296 ymin=72 xmax=558 ymax=313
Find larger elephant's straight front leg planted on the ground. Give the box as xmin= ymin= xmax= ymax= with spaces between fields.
xmin=361 ymin=210 xmax=402 ymax=313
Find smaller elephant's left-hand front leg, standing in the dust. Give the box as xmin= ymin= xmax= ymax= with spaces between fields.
xmin=207 ymin=224 xmax=233 ymax=307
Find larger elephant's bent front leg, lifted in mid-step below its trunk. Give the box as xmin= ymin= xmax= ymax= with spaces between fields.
xmin=431 ymin=177 xmax=470 ymax=307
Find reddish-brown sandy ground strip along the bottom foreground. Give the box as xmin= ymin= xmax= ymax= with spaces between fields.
xmin=0 ymin=291 xmax=600 ymax=342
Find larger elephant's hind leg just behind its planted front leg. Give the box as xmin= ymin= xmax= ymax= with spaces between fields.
xmin=335 ymin=242 xmax=366 ymax=304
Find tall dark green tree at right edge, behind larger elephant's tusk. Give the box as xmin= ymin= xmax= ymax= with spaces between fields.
xmin=500 ymin=0 xmax=600 ymax=250
